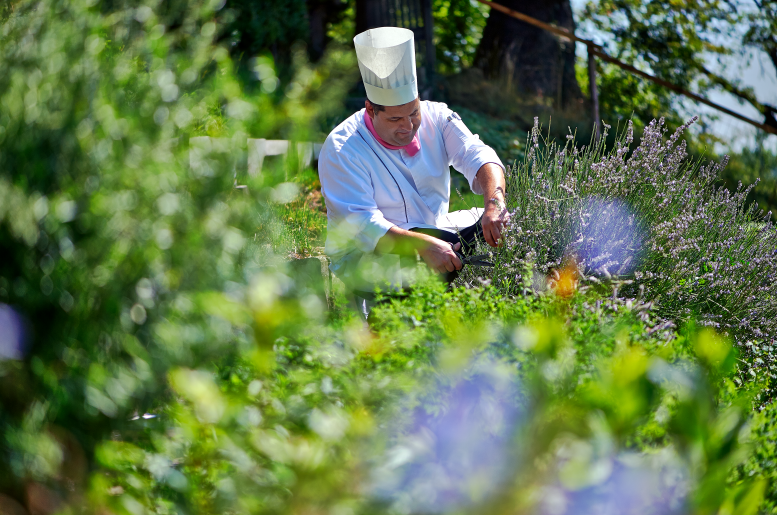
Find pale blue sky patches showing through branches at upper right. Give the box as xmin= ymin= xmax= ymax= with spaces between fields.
xmin=571 ymin=0 xmax=777 ymax=152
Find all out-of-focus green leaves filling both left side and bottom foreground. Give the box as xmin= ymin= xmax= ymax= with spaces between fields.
xmin=0 ymin=0 xmax=774 ymax=514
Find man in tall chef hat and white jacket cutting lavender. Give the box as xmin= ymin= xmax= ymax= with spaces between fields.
xmin=318 ymin=27 xmax=505 ymax=306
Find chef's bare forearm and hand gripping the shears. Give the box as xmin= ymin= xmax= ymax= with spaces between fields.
xmin=375 ymin=226 xmax=462 ymax=273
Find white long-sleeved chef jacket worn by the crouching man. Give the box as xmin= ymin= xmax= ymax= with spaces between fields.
xmin=318 ymin=101 xmax=504 ymax=290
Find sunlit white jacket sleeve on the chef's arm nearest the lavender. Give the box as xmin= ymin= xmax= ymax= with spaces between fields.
xmin=440 ymin=107 xmax=505 ymax=195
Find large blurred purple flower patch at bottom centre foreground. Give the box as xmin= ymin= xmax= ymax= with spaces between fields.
xmin=371 ymin=362 xmax=521 ymax=513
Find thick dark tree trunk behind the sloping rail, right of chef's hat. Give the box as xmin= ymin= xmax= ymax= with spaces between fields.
xmin=474 ymin=0 xmax=583 ymax=108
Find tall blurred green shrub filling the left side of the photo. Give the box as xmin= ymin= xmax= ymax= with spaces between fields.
xmin=0 ymin=0 xmax=352 ymax=511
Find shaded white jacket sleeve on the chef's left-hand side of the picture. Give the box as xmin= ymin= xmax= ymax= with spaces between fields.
xmin=318 ymin=148 xmax=395 ymax=255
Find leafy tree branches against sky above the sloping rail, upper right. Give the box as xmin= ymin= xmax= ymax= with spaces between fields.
xmin=583 ymin=0 xmax=777 ymax=130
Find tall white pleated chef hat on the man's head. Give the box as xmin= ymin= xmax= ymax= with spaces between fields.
xmin=353 ymin=27 xmax=418 ymax=106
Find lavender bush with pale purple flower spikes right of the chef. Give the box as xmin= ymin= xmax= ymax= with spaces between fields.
xmin=462 ymin=118 xmax=777 ymax=390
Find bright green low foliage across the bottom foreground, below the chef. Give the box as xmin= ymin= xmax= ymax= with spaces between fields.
xmin=36 ymin=270 xmax=763 ymax=513
